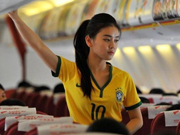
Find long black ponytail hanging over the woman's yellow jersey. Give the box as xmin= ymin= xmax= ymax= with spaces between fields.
xmin=73 ymin=20 xmax=93 ymax=99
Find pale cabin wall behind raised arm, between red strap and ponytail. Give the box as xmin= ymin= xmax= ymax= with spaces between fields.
xmin=26 ymin=41 xmax=75 ymax=88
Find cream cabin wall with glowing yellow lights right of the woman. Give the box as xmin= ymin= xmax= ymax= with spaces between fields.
xmin=113 ymin=45 xmax=180 ymax=92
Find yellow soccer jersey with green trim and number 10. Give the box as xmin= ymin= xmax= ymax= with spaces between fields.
xmin=52 ymin=57 xmax=141 ymax=125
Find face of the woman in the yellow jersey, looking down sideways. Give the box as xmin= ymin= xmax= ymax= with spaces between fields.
xmin=90 ymin=26 xmax=120 ymax=60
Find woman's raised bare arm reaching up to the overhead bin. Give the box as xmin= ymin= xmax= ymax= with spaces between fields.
xmin=9 ymin=11 xmax=58 ymax=72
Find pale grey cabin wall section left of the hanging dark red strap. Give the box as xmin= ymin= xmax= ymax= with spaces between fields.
xmin=0 ymin=43 xmax=22 ymax=89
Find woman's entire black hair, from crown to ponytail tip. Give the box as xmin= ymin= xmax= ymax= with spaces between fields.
xmin=73 ymin=13 xmax=121 ymax=99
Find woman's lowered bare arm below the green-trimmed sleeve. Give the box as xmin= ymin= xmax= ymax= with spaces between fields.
xmin=126 ymin=107 xmax=143 ymax=134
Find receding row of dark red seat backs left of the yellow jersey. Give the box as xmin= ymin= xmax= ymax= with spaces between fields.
xmin=7 ymin=89 xmax=69 ymax=117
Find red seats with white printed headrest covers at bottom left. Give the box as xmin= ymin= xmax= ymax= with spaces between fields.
xmin=0 ymin=109 xmax=93 ymax=135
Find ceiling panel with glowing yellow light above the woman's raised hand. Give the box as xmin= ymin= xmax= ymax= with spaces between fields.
xmin=0 ymin=0 xmax=74 ymax=16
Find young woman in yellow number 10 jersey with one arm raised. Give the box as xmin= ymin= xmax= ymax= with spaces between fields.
xmin=9 ymin=11 xmax=143 ymax=133
